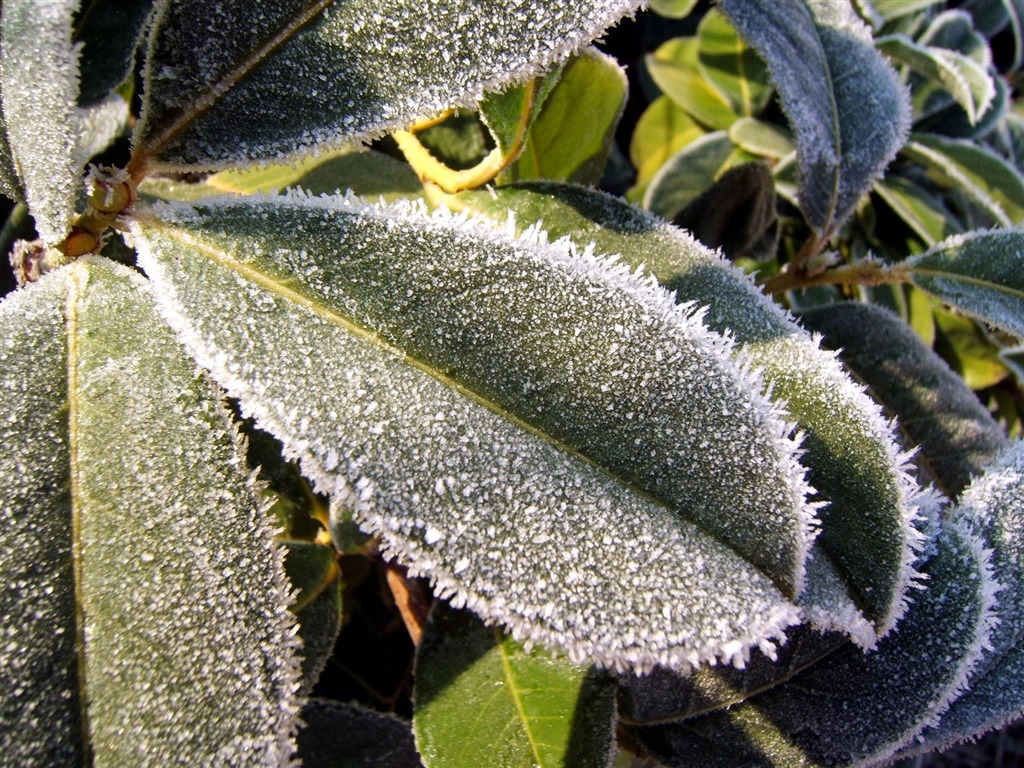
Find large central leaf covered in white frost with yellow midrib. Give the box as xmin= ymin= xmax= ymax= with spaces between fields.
xmin=136 ymin=196 xmax=813 ymax=669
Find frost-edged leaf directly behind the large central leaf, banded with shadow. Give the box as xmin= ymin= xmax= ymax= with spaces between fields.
xmin=461 ymin=183 xmax=931 ymax=633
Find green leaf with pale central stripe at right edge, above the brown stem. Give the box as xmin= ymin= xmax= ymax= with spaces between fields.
xmin=903 ymin=135 xmax=1024 ymax=226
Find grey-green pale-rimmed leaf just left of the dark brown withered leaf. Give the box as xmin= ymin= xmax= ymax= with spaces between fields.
xmin=643 ymin=131 xmax=735 ymax=219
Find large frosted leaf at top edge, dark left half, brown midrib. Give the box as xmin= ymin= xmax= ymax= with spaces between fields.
xmin=136 ymin=0 xmax=640 ymax=168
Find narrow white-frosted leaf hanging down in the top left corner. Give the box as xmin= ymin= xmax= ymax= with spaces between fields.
xmin=0 ymin=0 xmax=80 ymax=245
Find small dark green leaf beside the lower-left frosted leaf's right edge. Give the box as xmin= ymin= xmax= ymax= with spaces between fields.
xmin=282 ymin=541 xmax=341 ymax=696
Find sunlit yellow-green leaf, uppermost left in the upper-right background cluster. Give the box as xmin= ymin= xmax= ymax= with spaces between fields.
xmin=644 ymin=38 xmax=739 ymax=130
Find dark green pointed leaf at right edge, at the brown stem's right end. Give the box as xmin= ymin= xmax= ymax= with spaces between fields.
xmin=901 ymin=229 xmax=1024 ymax=337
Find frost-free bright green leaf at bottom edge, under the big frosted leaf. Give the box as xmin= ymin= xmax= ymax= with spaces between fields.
xmin=413 ymin=603 xmax=615 ymax=768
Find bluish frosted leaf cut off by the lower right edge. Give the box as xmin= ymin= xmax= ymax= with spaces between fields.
xmin=909 ymin=440 xmax=1024 ymax=753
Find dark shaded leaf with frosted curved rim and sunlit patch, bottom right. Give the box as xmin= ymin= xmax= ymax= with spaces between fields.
xmin=639 ymin=526 xmax=994 ymax=768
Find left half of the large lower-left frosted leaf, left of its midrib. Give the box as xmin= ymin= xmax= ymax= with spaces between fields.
xmin=0 ymin=273 xmax=83 ymax=768
